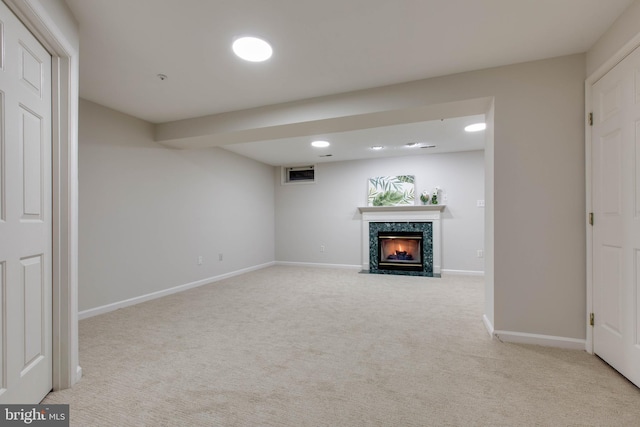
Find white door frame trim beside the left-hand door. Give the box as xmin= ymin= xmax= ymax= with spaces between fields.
xmin=3 ymin=0 xmax=82 ymax=390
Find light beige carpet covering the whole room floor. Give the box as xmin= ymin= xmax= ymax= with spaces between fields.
xmin=45 ymin=266 xmax=640 ymax=426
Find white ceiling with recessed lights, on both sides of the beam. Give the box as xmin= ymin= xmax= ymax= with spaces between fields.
xmin=66 ymin=0 xmax=633 ymax=164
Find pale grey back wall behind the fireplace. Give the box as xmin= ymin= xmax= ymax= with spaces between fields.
xmin=275 ymin=151 xmax=484 ymax=271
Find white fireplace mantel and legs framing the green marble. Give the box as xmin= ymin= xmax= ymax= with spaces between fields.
xmin=358 ymin=205 xmax=445 ymax=276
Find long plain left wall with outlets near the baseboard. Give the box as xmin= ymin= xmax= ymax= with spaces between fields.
xmin=79 ymin=100 xmax=274 ymax=311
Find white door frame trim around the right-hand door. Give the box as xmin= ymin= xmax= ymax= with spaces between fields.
xmin=584 ymin=33 xmax=640 ymax=354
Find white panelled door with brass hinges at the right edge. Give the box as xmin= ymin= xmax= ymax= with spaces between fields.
xmin=592 ymin=43 xmax=640 ymax=386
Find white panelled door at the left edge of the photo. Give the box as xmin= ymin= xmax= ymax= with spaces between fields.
xmin=0 ymin=2 xmax=52 ymax=404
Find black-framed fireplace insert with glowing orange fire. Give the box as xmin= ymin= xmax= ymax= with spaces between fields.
xmin=378 ymin=231 xmax=423 ymax=271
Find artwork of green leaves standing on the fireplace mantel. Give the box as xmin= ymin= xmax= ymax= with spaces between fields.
xmin=368 ymin=175 xmax=415 ymax=206
